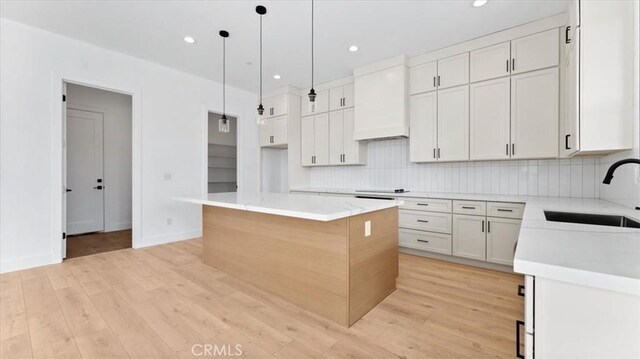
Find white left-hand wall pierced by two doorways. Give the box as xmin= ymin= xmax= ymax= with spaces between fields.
xmin=0 ymin=18 xmax=259 ymax=272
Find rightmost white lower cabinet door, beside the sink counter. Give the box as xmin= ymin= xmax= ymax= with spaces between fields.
xmin=487 ymin=217 xmax=522 ymax=266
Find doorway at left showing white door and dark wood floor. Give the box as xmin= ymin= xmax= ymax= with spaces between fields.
xmin=63 ymin=83 xmax=133 ymax=258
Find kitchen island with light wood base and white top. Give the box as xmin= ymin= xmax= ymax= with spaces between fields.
xmin=182 ymin=193 xmax=402 ymax=327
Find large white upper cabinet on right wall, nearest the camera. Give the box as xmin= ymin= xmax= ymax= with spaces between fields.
xmin=559 ymin=0 xmax=638 ymax=156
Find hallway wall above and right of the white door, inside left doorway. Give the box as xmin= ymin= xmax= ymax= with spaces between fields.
xmin=67 ymin=84 xmax=133 ymax=232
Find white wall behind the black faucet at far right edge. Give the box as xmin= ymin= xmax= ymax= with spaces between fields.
xmin=600 ymin=1 xmax=640 ymax=208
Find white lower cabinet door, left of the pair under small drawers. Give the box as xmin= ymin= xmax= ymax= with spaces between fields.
xmin=453 ymin=214 xmax=486 ymax=261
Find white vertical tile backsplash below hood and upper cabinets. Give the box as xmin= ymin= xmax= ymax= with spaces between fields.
xmin=310 ymin=138 xmax=602 ymax=198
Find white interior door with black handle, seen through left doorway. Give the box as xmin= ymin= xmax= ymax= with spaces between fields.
xmin=66 ymin=108 xmax=104 ymax=235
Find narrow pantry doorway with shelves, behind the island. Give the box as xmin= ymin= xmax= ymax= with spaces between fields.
xmin=207 ymin=112 xmax=238 ymax=193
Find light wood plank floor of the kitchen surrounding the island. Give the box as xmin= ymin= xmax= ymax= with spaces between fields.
xmin=0 ymin=240 xmax=523 ymax=359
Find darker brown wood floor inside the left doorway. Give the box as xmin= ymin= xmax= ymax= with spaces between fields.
xmin=67 ymin=229 xmax=131 ymax=259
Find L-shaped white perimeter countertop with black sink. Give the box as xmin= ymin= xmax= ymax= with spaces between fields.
xmin=294 ymin=188 xmax=640 ymax=295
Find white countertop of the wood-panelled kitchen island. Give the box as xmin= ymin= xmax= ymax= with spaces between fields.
xmin=176 ymin=192 xmax=402 ymax=221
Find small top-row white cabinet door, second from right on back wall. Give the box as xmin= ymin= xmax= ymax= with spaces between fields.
xmin=469 ymin=41 xmax=511 ymax=82
